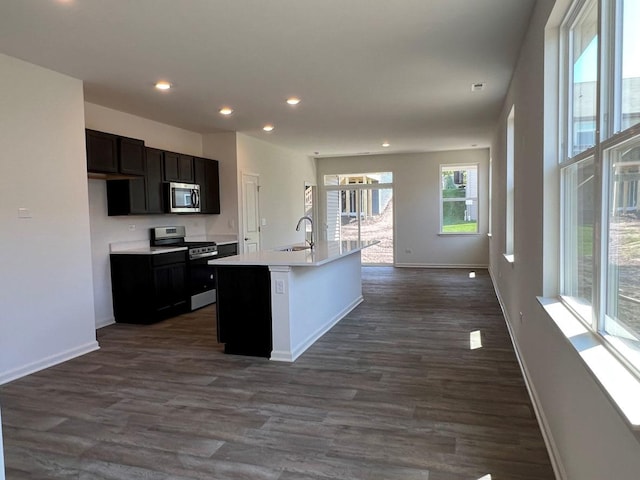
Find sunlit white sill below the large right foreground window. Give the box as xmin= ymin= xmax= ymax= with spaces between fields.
xmin=538 ymin=297 xmax=640 ymax=431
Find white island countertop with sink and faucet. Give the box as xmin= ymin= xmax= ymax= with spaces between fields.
xmin=208 ymin=240 xmax=379 ymax=267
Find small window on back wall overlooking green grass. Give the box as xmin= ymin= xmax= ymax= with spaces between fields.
xmin=440 ymin=165 xmax=478 ymax=233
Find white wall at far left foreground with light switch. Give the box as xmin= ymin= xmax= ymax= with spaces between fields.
xmin=0 ymin=54 xmax=98 ymax=384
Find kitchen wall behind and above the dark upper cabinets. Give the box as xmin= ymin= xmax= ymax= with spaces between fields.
xmin=84 ymin=103 xmax=210 ymax=327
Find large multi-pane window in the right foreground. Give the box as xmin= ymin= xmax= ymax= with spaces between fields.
xmin=560 ymin=0 xmax=640 ymax=373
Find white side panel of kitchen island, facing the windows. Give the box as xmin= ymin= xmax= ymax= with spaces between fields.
xmin=271 ymin=252 xmax=362 ymax=361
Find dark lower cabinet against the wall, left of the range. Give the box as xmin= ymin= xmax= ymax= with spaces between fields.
xmin=110 ymin=251 xmax=189 ymax=324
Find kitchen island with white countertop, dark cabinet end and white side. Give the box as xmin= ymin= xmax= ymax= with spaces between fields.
xmin=209 ymin=241 xmax=378 ymax=362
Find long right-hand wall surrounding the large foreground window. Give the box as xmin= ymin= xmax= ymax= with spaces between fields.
xmin=490 ymin=0 xmax=640 ymax=480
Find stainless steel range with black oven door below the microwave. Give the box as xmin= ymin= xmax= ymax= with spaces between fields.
xmin=150 ymin=226 xmax=218 ymax=310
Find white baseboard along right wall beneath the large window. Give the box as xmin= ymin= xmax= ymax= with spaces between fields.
xmin=489 ymin=268 xmax=568 ymax=480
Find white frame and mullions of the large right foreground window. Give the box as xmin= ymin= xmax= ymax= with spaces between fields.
xmin=558 ymin=0 xmax=640 ymax=379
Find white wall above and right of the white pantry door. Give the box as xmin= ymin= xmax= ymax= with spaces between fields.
xmin=237 ymin=133 xmax=316 ymax=249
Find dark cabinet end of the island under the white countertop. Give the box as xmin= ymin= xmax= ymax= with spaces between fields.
xmin=216 ymin=266 xmax=272 ymax=358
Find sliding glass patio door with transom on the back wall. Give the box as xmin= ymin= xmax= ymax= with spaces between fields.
xmin=325 ymin=172 xmax=393 ymax=265
